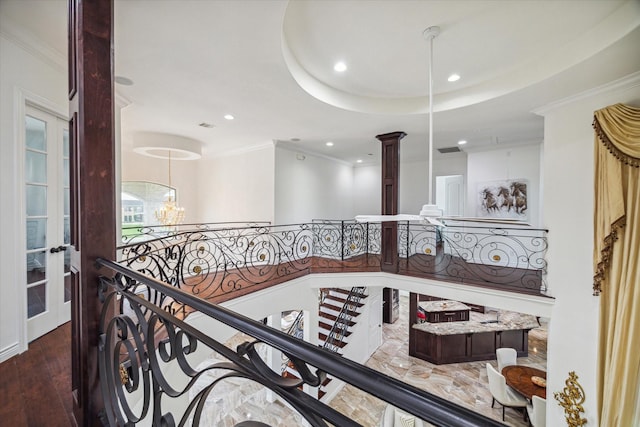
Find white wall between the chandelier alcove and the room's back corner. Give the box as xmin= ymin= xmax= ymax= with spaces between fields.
xmin=197 ymin=144 xmax=275 ymax=222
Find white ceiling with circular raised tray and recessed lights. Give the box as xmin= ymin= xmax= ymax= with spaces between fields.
xmin=0 ymin=0 xmax=640 ymax=164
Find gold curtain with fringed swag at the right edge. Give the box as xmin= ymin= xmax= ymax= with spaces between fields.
xmin=593 ymin=104 xmax=640 ymax=427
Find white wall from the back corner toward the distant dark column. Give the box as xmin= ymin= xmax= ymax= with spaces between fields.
xmin=275 ymin=146 xmax=358 ymax=224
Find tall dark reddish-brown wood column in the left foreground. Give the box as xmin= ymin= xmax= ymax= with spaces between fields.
xmin=69 ymin=0 xmax=116 ymax=426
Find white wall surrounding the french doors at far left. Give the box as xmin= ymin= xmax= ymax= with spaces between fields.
xmin=0 ymin=32 xmax=69 ymax=362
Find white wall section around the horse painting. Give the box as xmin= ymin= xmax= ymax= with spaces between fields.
xmin=465 ymin=144 xmax=542 ymax=227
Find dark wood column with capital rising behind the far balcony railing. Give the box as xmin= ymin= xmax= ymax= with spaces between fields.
xmin=376 ymin=132 xmax=407 ymax=273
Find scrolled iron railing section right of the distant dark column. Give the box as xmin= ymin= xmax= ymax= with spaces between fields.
xmin=398 ymin=222 xmax=547 ymax=293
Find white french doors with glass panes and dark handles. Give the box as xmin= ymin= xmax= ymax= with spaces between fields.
xmin=24 ymin=106 xmax=71 ymax=341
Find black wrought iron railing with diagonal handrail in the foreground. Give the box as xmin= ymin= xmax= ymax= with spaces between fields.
xmin=97 ymin=259 xmax=501 ymax=427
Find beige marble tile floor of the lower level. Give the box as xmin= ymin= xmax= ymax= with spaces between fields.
xmin=190 ymin=296 xmax=547 ymax=427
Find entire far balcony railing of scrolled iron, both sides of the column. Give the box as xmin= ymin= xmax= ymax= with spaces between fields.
xmin=119 ymin=220 xmax=547 ymax=302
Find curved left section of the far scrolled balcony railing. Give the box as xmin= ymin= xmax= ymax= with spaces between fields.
xmin=119 ymin=224 xmax=313 ymax=299
